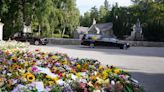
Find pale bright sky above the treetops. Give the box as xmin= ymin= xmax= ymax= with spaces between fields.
xmin=76 ymin=0 xmax=131 ymax=15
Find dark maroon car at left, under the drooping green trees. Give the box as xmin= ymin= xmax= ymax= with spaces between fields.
xmin=10 ymin=32 xmax=48 ymax=45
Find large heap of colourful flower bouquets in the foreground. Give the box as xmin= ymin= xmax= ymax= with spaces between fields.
xmin=0 ymin=49 xmax=142 ymax=92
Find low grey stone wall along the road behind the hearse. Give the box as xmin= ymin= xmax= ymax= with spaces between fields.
xmin=48 ymin=38 xmax=164 ymax=47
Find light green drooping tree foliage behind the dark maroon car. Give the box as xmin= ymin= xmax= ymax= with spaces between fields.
xmin=0 ymin=0 xmax=80 ymax=38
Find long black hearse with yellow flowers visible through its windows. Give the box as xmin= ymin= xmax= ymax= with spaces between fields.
xmin=81 ymin=35 xmax=130 ymax=49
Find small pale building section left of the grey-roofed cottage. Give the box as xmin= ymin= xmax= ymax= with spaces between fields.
xmin=73 ymin=26 xmax=89 ymax=39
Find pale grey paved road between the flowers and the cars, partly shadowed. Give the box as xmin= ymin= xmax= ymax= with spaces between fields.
xmin=29 ymin=45 xmax=164 ymax=92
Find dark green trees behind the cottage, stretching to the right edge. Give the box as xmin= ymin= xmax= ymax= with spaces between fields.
xmin=80 ymin=0 xmax=164 ymax=41
